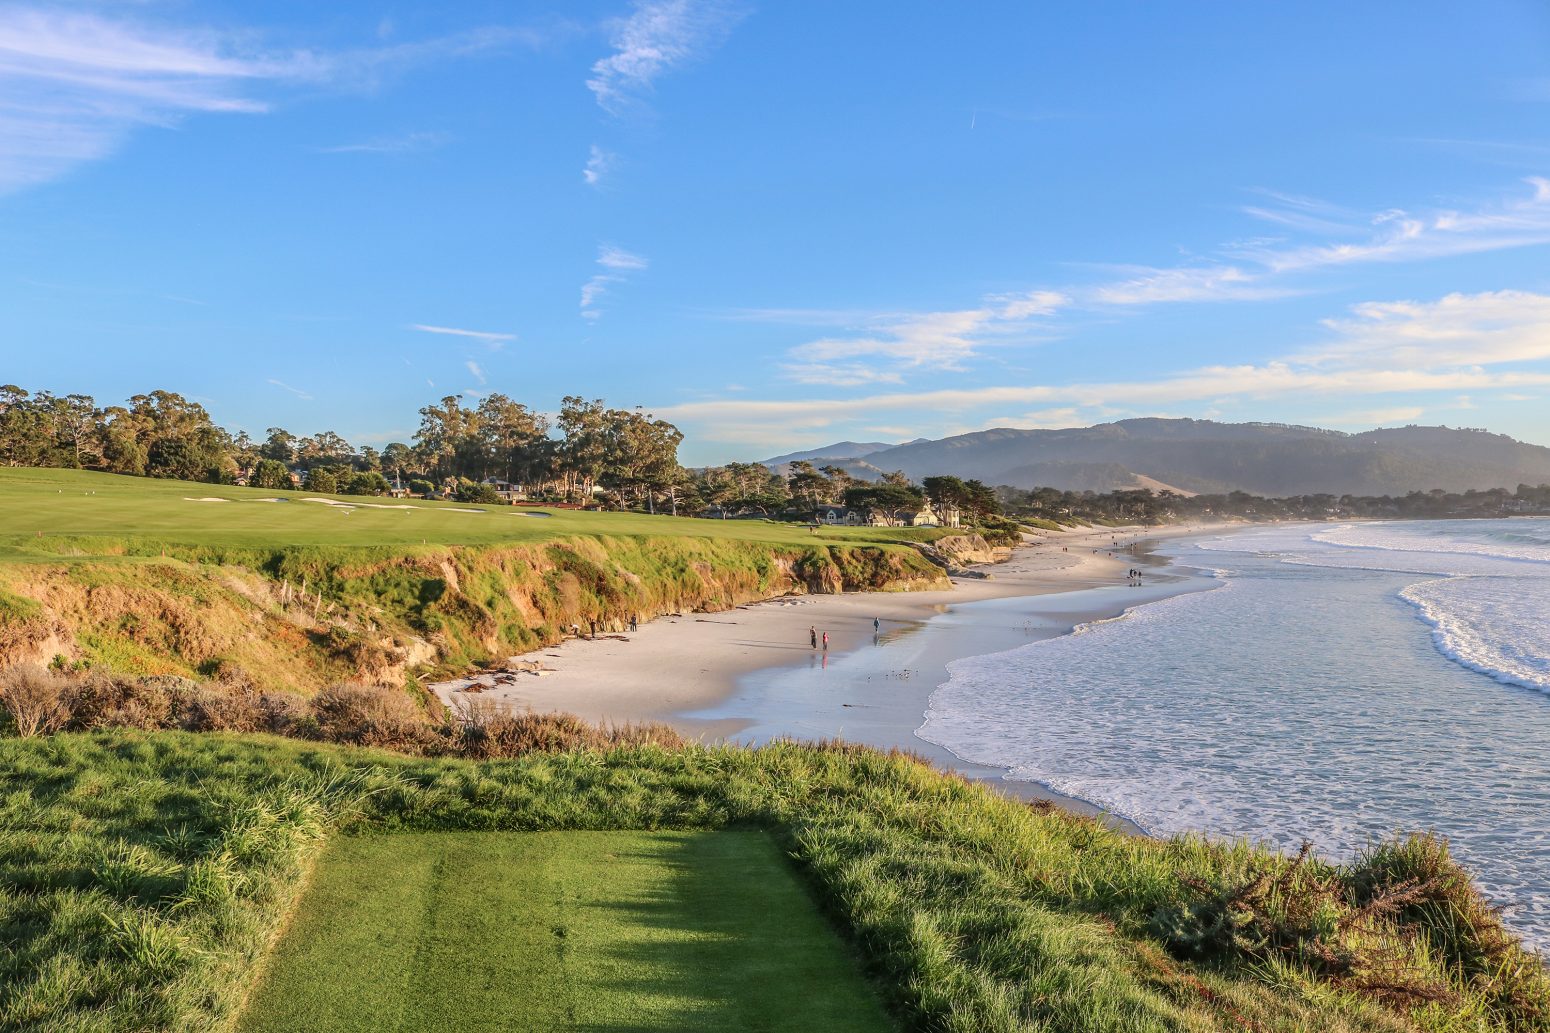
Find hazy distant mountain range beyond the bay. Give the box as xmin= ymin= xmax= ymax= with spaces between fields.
xmin=764 ymin=419 xmax=1550 ymax=496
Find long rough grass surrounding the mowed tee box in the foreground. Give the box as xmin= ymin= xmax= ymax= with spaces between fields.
xmin=0 ymin=732 xmax=1550 ymax=1033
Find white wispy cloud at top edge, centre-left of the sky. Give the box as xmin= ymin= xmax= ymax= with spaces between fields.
xmin=586 ymin=0 xmax=744 ymax=113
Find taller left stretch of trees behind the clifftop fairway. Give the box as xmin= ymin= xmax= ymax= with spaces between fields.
xmin=0 ymin=385 xmax=688 ymax=509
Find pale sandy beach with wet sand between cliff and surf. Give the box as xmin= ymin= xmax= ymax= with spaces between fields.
xmin=432 ymin=523 xmax=1245 ymax=831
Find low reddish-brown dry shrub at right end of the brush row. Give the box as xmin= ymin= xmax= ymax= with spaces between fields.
xmin=454 ymin=698 xmax=685 ymax=758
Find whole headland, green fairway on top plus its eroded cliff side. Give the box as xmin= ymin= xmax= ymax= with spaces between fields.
xmin=0 ymin=470 xmax=942 ymax=692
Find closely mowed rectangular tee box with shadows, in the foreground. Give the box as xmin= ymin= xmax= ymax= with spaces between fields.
xmin=237 ymin=831 xmax=894 ymax=1033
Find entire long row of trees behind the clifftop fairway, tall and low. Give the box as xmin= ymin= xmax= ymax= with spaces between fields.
xmin=0 ymin=385 xmax=998 ymax=523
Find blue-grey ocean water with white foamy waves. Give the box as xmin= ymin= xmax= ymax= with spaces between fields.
xmin=918 ymin=520 xmax=1550 ymax=949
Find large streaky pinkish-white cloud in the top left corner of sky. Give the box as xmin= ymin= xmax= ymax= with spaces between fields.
xmin=0 ymin=5 xmax=541 ymax=192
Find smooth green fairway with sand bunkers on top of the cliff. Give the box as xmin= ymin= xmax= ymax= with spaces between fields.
xmin=0 ymin=468 xmax=946 ymax=561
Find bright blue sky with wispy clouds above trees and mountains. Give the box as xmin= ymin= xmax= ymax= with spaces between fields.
xmin=0 ymin=0 xmax=1550 ymax=462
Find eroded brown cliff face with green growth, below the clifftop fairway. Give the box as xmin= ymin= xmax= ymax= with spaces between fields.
xmin=0 ymin=537 xmax=942 ymax=693
